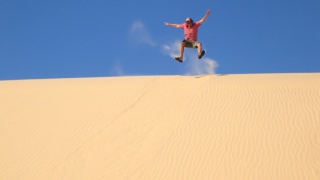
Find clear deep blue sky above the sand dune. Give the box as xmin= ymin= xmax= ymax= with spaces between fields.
xmin=0 ymin=0 xmax=320 ymax=80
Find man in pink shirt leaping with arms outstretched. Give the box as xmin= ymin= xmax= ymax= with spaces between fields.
xmin=164 ymin=9 xmax=211 ymax=62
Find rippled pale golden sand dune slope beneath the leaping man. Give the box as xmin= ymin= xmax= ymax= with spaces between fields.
xmin=0 ymin=73 xmax=320 ymax=180
